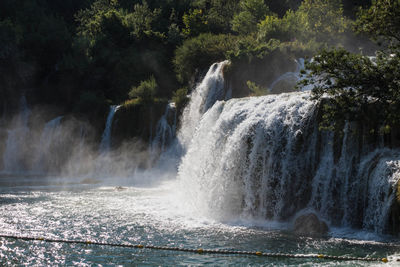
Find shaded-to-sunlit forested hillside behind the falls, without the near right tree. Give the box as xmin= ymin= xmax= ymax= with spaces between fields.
xmin=0 ymin=0 xmax=369 ymax=112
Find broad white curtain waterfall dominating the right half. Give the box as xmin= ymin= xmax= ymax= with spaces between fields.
xmin=178 ymin=63 xmax=400 ymax=233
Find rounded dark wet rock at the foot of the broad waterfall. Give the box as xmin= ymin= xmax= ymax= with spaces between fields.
xmin=294 ymin=213 xmax=329 ymax=236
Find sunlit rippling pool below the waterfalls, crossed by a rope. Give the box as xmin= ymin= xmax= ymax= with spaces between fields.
xmin=0 ymin=177 xmax=400 ymax=266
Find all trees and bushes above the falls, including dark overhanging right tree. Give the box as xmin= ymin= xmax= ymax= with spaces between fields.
xmin=0 ymin=0 xmax=400 ymax=143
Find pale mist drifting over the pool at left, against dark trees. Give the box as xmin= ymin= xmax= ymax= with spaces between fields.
xmin=0 ymin=101 xmax=166 ymax=187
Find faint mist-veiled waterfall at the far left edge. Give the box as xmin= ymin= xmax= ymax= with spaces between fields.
xmin=3 ymin=96 xmax=31 ymax=172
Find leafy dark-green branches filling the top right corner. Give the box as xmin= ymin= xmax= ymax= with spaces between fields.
xmin=356 ymin=0 xmax=400 ymax=48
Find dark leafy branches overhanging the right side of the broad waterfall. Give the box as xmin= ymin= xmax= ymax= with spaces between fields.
xmin=302 ymin=49 xmax=400 ymax=129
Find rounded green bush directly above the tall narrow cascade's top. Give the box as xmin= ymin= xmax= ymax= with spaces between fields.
xmin=173 ymin=33 xmax=237 ymax=83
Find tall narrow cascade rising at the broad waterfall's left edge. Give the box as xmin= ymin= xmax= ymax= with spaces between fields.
xmin=178 ymin=61 xmax=229 ymax=153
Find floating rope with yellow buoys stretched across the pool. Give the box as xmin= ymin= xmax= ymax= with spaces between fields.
xmin=0 ymin=235 xmax=388 ymax=263
